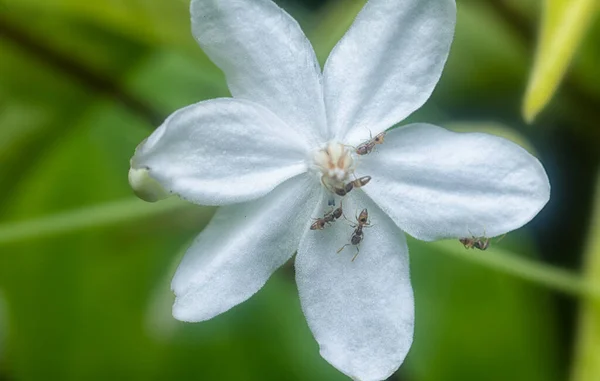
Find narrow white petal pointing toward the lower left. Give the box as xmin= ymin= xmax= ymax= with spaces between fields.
xmin=172 ymin=175 xmax=321 ymax=321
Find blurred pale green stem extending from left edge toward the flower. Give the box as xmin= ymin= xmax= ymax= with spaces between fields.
xmin=0 ymin=198 xmax=189 ymax=245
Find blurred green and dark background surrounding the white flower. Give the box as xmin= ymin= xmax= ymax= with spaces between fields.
xmin=0 ymin=0 xmax=600 ymax=381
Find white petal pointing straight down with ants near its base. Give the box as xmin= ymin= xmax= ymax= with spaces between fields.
xmin=296 ymin=190 xmax=414 ymax=381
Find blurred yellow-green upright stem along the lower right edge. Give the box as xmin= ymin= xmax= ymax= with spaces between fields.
xmin=571 ymin=173 xmax=600 ymax=381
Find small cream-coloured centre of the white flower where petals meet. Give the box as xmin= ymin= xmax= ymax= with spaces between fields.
xmin=313 ymin=142 xmax=354 ymax=191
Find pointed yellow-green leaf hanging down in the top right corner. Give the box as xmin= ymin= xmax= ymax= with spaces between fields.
xmin=523 ymin=0 xmax=598 ymax=123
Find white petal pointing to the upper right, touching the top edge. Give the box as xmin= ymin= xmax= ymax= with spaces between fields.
xmin=324 ymin=0 xmax=456 ymax=144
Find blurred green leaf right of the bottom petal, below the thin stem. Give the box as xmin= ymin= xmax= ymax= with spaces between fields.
xmin=405 ymin=234 xmax=562 ymax=381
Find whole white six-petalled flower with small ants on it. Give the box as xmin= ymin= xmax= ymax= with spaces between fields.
xmin=131 ymin=0 xmax=550 ymax=381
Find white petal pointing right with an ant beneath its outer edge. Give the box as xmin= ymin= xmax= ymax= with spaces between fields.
xmin=361 ymin=124 xmax=550 ymax=240
